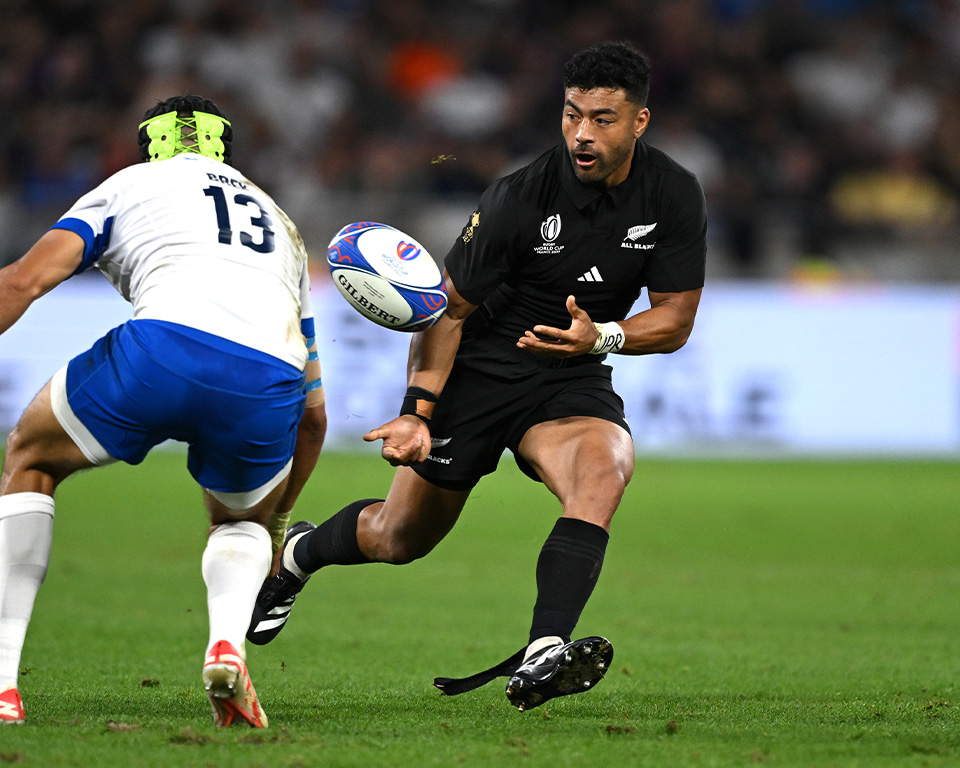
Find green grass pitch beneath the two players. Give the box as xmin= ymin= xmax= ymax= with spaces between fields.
xmin=0 ymin=453 xmax=960 ymax=768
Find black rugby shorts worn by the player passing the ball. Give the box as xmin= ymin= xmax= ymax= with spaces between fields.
xmin=413 ymin=362 xmax=630 ymax=491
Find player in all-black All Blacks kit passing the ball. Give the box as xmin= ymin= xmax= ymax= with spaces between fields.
xmin=247 ymin=42 xmax=706 ymax=710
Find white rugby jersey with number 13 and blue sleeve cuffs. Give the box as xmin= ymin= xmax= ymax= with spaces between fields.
xmin=52 ymin=154 xmax=313 ymax=370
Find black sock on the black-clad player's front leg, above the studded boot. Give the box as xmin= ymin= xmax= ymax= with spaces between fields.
xmin=530 ymin=517 xmax=610 ymax=642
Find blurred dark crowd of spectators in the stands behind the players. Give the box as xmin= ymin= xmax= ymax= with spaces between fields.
xmin=0 ymin=0 xmax=960 ymax=281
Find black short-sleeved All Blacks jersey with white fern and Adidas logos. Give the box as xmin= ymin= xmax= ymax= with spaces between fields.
xmin=444 ymin=140 xmax=707 ymax=376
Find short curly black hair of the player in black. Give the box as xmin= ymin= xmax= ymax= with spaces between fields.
xmin=563 ymin=41 xmax=651 ymax=107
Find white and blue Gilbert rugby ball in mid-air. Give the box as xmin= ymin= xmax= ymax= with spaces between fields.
xmin=327 ymin=221 xmax=447 ymax=332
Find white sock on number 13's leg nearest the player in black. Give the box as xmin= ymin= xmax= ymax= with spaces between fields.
xmin=202 ymin=520 xmax=273 ymax=657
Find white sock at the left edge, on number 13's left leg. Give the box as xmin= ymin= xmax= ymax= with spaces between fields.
xmin=0 ymin=493 xmax=54 ymax=690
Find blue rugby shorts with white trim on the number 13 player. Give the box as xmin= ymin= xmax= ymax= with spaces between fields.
xmin=52 ymin=320 xmax=304 ymax=495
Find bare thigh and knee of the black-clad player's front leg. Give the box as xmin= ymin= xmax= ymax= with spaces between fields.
xmin=519 ymin=416 xmax=635 ymax=527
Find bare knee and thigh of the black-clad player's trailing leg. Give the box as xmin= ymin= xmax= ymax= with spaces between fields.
xmin=357 ymin=467 xmax=470 ymax=562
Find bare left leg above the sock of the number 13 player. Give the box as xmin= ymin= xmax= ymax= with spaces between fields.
xmin=0 ymin=382 xmax=94 ymax=495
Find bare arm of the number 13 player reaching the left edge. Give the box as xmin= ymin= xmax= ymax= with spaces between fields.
xmin=0 ymin=229 xmax=84 ymax=333
